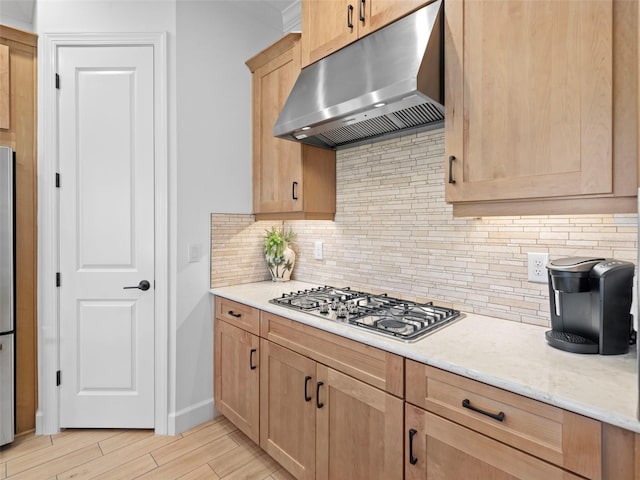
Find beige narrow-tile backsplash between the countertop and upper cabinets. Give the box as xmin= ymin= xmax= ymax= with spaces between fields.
xmin=211 ymin=129 xmax=637 ymax=325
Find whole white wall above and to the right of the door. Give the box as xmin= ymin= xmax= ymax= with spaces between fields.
xmin=34 ymin=0 xmax=282 ymax=434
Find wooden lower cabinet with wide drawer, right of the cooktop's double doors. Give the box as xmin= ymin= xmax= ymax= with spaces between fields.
xmin=405 ymin=359 xmax=604 ymax=480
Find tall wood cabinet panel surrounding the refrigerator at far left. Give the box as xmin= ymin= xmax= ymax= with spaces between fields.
xmin=0 ymin=25 xmax=38 ymax=434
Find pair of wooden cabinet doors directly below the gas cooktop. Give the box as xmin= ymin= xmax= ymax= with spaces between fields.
xmin=260 ymin=339 xmax=403 ymax=480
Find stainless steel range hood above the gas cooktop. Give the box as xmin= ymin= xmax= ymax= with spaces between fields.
xmin=273 ymin=0 xmax=444 ymax=149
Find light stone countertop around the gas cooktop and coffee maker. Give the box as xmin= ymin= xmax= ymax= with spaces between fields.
xmin=211 ymin=280 xmax=640 ymax=433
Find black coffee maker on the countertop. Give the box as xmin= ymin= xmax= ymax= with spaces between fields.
xmin=546 ymin=257 xmax=635 ymax=355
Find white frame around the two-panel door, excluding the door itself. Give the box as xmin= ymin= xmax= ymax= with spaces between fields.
xmin=36 ymin=33 xmax=169 ymax=435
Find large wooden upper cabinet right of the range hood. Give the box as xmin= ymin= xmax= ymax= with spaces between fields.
xmin=445 ymin=0 xmax=638 ymax=215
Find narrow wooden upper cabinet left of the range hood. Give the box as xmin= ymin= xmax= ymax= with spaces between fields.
xmin=246 ymin=33 xmax=336 ymax=220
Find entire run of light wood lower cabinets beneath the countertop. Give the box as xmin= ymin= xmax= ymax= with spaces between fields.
xmin=214 ymin=298 xmax=640 ymax=480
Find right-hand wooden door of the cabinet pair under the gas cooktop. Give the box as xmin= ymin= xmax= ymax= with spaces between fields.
xmin=316 ymin=364 xmax=402 ymax=480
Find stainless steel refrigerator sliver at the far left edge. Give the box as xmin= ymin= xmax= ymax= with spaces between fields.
xmin=0 ymin=147 xmax=15 ymax=445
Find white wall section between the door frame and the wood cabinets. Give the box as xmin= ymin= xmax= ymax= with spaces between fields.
xmin=175 ymin=0 xmax=283 ymax=431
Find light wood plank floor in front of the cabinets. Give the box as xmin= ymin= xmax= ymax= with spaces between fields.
xmin=0 ymin=417 xmax=293 ymax=480
